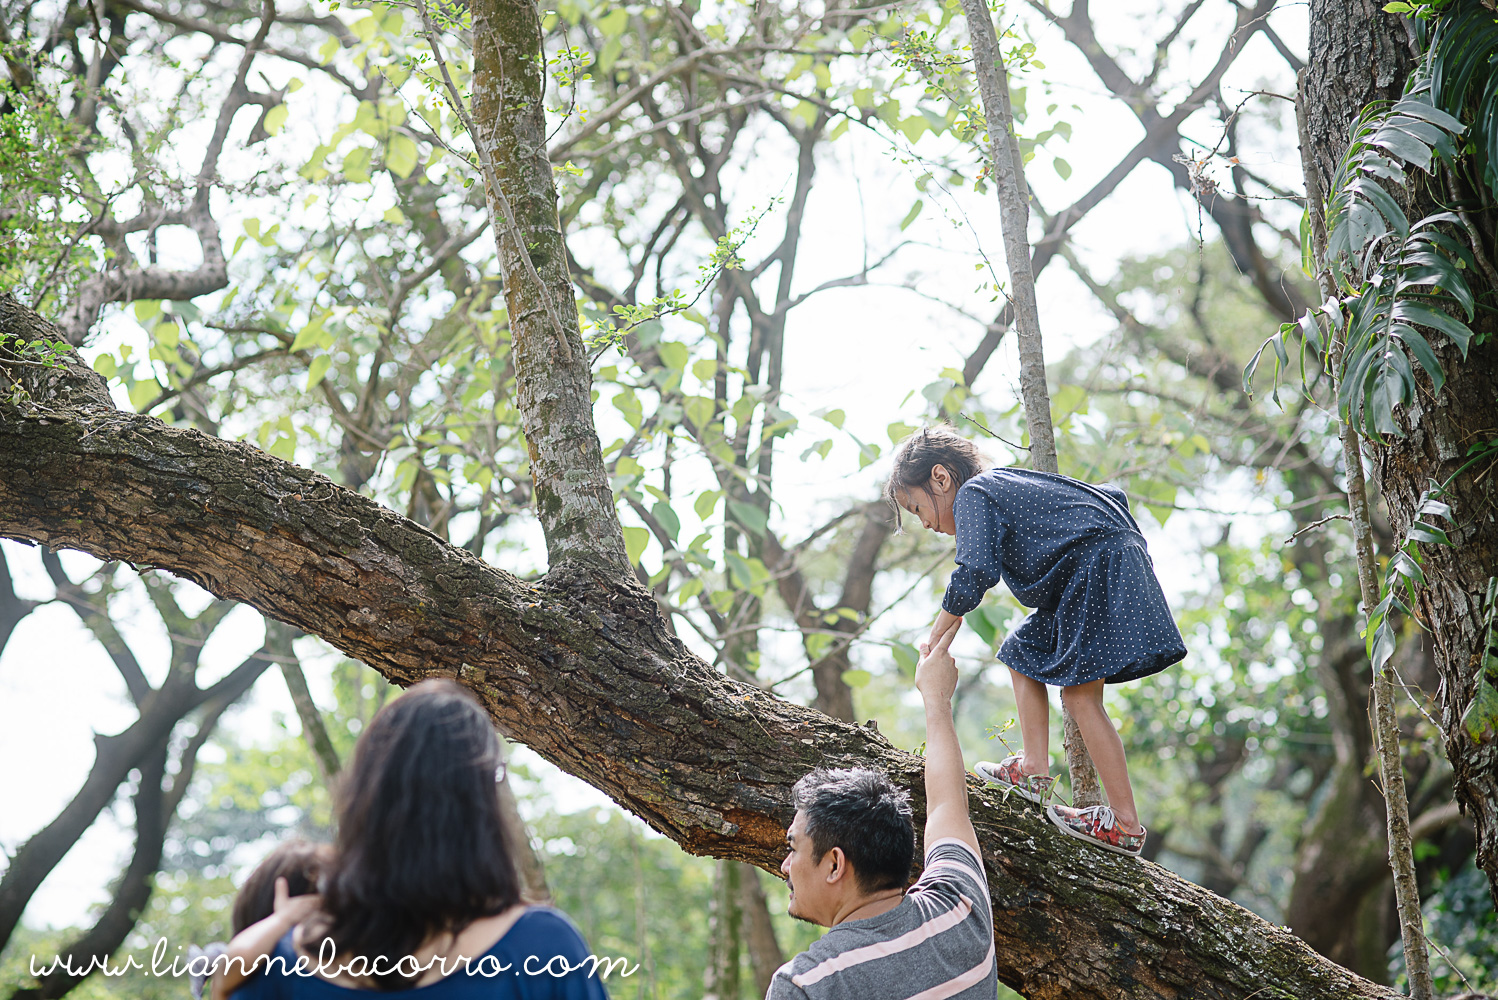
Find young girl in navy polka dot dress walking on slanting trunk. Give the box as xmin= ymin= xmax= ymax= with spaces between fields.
xmin=885 ymin=428 xmax=1186 ymax=856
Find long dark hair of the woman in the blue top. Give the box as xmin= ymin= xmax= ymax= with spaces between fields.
xmin=309 ymin=680 xmax=520 ymax=990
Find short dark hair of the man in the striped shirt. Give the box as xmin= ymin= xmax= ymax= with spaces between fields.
xmin=791 ymin=768 xmax=915 ymax=892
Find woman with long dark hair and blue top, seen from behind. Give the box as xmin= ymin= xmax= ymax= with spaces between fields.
xmin=216 ymin=681 xmax=608 ymax=1000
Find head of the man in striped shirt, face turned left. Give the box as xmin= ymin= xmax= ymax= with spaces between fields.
xmin=780 ymin=768 xmax=915 ymax=927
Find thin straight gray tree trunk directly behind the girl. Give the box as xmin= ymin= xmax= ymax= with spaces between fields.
xmin=962 ymin=0 xmax=1103 ymax=807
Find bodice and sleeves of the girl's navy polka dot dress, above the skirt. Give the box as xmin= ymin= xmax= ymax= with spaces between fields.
xmin=941 ymin=469 xmax=1144 ymax=617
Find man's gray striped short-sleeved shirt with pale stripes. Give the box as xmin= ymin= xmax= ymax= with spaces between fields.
xmin=765 ymin=837 xmax=999 ymax=1000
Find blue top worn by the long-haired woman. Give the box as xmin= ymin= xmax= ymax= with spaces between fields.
xmin=232 ymin=906 xmax=608 ymax=1000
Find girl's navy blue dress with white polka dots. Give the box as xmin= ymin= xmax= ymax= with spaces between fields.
xmin=942 ymin=469 xmax=1186 ymax=687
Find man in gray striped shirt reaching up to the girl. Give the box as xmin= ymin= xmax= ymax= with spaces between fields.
xmin=765 ymin=630 xmax=998 ymax=1000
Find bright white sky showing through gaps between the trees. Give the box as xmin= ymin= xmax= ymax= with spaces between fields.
xmin=0 ymin=0 xmax=1306 ymax=927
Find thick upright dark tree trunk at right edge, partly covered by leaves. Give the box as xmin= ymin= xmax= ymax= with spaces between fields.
xmin=1306 ymin=0 xmax=1498 ymax=903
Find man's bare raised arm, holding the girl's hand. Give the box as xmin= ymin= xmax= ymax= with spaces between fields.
xmin=915 ymin=629 xmax=981 ymax=856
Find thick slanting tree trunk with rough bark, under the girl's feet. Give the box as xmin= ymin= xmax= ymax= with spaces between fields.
xmin=0 ymin=306 xmax=1395 ymax=1000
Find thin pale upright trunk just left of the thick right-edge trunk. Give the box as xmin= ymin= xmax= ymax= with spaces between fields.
xmin=1296 ymin=70 xmax=1431 ymax=1000
